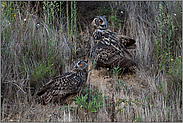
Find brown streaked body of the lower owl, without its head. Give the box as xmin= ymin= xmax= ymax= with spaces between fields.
xmin=37 ymin=71 xmax=88 ymax=104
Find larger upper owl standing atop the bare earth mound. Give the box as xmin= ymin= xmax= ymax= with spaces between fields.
xmin=91 ymin=16 xmax=136 ymax=68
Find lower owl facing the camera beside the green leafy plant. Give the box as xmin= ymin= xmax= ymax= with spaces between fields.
xmin=37 ymin=60 xmax=88 ymax=105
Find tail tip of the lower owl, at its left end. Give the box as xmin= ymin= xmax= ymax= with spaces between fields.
xmin=36 ymin=94 xmax=53 ymax=105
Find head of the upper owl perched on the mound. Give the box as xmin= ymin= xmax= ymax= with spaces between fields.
xmin=91 ymin=16 xmax=107 ymax=30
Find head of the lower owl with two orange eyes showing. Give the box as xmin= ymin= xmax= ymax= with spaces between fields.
xmin=71 ymin=60 xmax=88 ymax=71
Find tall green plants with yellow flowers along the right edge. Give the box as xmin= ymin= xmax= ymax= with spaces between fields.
xmin=154 ymin=4 xmax=182 ymax=89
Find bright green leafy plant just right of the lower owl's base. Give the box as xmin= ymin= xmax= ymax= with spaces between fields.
xmin=74 ymin=88 xmax=107 ymax=113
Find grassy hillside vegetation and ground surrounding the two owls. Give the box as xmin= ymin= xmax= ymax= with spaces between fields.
xmin=1 ymin=1 xmax=182 ymax=122
